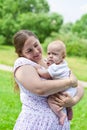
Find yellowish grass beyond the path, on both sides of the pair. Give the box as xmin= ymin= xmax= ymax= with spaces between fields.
xmin=0 ymin=45 xmax=87 ymax=81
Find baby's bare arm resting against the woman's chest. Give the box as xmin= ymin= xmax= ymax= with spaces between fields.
xmin=37 ymin=68 xmax=51 ymax=79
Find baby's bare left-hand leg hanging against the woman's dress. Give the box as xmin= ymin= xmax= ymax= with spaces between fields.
xmin=48 ymin=100 xmax=67 ymax=125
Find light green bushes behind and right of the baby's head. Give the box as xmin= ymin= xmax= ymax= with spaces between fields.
xmin=43 ymin=29 xmax=87 ymax=58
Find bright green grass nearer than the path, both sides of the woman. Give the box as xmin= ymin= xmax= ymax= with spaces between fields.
xmin=0 ymin=70 xmax=87 ymax=130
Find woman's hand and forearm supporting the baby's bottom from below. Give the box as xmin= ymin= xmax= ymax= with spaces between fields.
xmin=48 ymin=82 xmax=84 ymax=110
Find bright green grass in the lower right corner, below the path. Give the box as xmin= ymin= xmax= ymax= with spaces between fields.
xmin=71 ymin=88 xmax=87 ymax=130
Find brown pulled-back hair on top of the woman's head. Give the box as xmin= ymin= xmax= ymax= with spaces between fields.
xmin=13 ymin=30 xmax=38 ymax=57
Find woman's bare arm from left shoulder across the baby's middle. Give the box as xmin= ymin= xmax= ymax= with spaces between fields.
xmin=15 ymin=65 xmax=77 ymax=95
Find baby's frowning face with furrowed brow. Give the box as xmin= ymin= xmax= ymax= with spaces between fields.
xmin=47 ymin=44 xmax=63 ymax=65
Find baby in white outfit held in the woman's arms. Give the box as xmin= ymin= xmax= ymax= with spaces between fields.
xmin=37 ymin=40 xmax=77 ymax=125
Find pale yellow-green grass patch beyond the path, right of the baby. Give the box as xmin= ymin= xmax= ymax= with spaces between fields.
xmin=67 ymin=57 xmax=87 ymax=81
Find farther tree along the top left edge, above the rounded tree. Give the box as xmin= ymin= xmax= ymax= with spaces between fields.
xmin=0 ymin=0 xmax=49 ymax=17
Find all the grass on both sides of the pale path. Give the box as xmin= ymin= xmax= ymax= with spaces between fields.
xmin=0 ymin=46 xmax=87 ymax=130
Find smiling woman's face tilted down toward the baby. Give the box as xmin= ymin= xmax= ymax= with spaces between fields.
xmin=22 ymin=36 xmax=42 ymax=63
